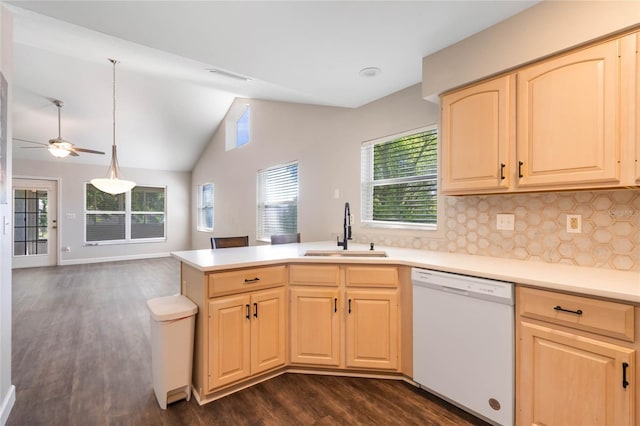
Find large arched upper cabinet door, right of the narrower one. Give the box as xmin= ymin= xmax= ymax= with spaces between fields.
xmin=515 ymin=40 xmax=620 ymax=188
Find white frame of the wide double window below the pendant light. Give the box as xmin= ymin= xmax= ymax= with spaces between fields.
xmin=83 ymin=182 xmax=168 ymax=246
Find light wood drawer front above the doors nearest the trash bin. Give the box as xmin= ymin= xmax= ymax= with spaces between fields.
xmin=209 ymin=266 xmax=286 ymax=297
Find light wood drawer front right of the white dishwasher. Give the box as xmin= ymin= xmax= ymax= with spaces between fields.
xmin=517 ymin=287 xmax=634 ymax=342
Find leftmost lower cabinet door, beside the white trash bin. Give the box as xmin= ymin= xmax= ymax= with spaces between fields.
xmin=209 ymin=295 xmax=251 ymax=390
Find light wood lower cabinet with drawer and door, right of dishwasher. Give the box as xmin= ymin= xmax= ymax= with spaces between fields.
xmin=516 ymin=288 xmax=640 ymax=426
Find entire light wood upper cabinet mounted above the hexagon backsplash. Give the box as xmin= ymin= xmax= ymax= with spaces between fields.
xmin=440 ymin=33 xmax=640 ymax=195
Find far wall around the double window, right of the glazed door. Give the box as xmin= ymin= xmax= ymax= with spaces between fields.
xmin=13 ymin=158 xmax=191 ymax=265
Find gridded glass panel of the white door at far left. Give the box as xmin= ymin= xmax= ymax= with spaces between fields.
xmin=13 ymin=189 xmax=49 ymax=256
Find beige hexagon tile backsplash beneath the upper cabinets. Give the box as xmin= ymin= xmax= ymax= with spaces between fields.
xmin=355 ymin=189 xmax=640 ymax=271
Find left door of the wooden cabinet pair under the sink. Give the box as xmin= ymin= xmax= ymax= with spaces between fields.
xmin=290 ymin=288 xmax=340 ymax=366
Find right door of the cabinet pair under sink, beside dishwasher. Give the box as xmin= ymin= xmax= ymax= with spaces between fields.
xmin=346 ymin=290 xmax=399 ymax=370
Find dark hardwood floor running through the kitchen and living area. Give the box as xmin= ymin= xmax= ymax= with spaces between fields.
xmin=8 ymin=258 xmax=485 ymax=425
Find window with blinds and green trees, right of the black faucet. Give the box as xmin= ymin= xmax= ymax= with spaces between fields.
xmin=361 ymin=126 xmax=438 ymax=229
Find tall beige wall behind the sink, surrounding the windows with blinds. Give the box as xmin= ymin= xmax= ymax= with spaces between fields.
xmin=192 ymin=85 xmax=438 ymax=248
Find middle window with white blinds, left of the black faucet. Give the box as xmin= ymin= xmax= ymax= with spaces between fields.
xmin=257 ymin=162 xmax=298 ymax=241
